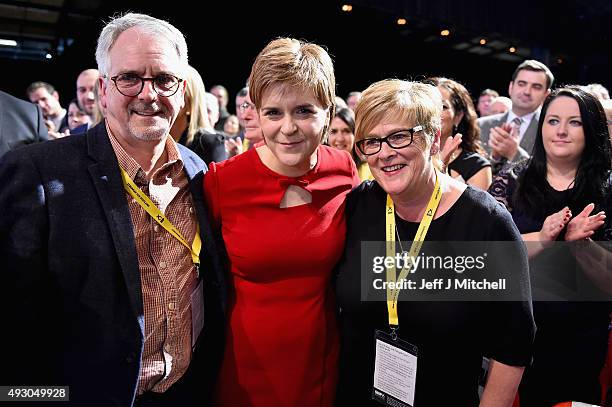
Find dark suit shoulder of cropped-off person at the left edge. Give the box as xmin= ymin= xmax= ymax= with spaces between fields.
xmin=0 ymin=91 xmax=47 ymax=157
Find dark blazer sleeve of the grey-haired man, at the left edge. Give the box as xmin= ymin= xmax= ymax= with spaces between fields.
xmin=0 ymin=147 xmax=54 ymax=385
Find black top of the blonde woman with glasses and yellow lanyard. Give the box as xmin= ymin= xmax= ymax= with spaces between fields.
xmin=337 ymin=181 xmax=535 ymax=407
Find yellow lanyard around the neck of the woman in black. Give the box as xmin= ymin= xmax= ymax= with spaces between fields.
xmin=385 ymin=171 xmax=442 ymax=329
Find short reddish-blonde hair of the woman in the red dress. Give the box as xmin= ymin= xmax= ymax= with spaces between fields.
xmin=249 ymin=38 xmax=336 ymax=119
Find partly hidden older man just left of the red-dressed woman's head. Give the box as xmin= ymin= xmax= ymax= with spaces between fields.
xmin=225 ymin=87 xmax=263 ymax=157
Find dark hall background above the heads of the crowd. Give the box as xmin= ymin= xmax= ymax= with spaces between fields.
xmin=0 ymin=0 xmax=612 ymax=111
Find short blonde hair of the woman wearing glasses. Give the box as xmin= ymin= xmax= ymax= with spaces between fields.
xmin=355 ymin=79 xmax=442 ymax=144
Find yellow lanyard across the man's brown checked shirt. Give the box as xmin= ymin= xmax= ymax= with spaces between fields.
xmin=121 ymin=168 xmax=202 ymax=272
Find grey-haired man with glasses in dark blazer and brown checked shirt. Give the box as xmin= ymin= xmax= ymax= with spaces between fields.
xmin=0 ymin=13 xmax=226 ymax=406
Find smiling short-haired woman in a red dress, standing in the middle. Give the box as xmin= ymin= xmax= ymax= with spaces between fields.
xmin=204 ymin=38 xmax=359 ymax=407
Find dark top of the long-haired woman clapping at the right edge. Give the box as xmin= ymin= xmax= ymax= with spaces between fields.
xmin=489 ymin=162 xmax=612 ymax=406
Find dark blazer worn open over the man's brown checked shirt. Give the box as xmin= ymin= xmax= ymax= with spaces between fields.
xmin=0 ymin=123 xmax=226 ymax=406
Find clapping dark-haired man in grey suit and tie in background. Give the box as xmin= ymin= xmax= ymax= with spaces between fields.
xmin=478 ymin=60 xmax=554 ymax=173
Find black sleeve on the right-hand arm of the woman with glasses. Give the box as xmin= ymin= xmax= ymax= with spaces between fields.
xmin=482 ymin=205 xmax=535 ymax=366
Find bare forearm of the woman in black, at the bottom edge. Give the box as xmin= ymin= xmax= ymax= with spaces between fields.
xmin=480 ymin=359 xmax=525 ymax=407
